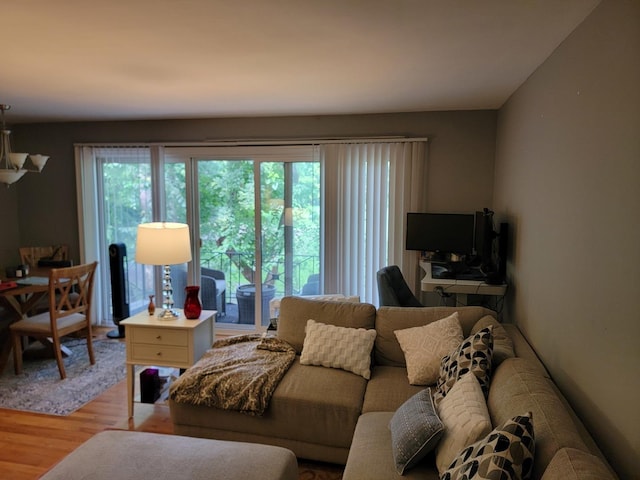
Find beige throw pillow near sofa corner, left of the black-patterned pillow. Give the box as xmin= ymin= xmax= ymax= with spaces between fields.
xmin=393 ymin=312 xmax=463 ymax=385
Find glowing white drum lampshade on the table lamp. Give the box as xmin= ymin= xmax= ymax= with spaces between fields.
xmin=136 ymin=222 xmax=191 ymax=265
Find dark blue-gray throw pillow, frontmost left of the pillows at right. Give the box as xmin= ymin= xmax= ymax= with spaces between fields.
xmin=389 ymin=388 xmax=444 ymax=475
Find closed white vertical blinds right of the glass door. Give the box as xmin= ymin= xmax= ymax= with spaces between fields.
xmin=321 ymin=141 xmax=427 ymax=304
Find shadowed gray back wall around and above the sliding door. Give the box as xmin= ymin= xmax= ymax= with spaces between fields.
xmin=0 ymin=111 xmax=497 ymax=267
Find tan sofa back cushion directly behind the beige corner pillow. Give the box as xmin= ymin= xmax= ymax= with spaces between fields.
xmin=374 ymin=307 xmax=495 ymax=367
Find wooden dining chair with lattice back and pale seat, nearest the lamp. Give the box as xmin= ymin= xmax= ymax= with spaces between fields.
xmin=9 ymin=262 xmax=98 ymax=379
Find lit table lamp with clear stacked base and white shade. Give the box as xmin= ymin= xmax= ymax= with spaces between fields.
xmin=136 ymin=222 xmax=191 ymax=319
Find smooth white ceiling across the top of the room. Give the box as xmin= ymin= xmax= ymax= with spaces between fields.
xmin=0 ymin=0 xmax=599 ymax=124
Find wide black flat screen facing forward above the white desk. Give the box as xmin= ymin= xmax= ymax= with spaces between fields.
xmin=406 ymin=213 xmax=475 ymax=255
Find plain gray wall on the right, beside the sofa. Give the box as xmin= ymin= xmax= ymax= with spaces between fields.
xmin=494 ymin=0 xmax=640 ymax=478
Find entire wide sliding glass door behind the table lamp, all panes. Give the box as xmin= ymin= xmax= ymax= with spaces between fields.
xmin=76 ymin=146 xmax=322 ymax=331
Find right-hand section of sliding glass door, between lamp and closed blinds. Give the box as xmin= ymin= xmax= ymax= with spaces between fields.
xmin=165 ymin=147 xmax=321 ymax=330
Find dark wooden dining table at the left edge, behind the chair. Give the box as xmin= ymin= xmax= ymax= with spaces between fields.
xmin=0 ymin=267 xmax=70 ymax=374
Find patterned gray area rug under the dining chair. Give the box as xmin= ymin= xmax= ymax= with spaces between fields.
xmin=0 ymin=339 xmax=126 ymax=415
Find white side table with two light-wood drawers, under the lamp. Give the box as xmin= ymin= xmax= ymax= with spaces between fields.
xmin=120 ymin=310 xmax=217 ymax=418
